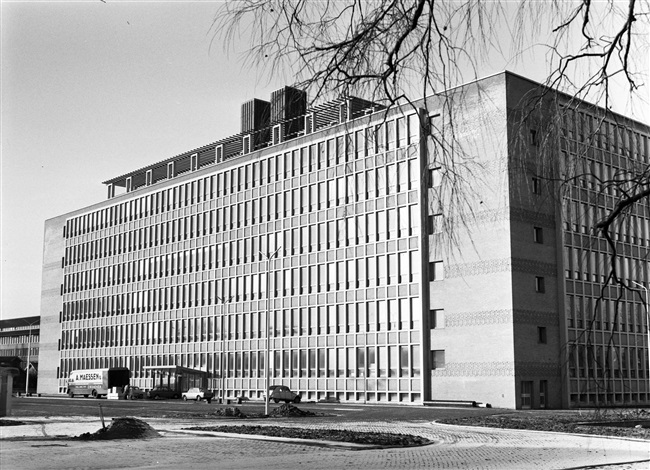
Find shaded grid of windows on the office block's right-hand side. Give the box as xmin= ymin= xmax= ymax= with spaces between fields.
xmin=561 ymin=111 xmax=650 ymax=406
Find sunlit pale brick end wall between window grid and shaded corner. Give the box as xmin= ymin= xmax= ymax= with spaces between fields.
xmin=422 ymin=75 xmax=516 ymax=408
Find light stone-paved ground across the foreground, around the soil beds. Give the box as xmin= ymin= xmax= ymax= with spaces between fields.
xmin=0 ymin=417 xmax=650 ymax=470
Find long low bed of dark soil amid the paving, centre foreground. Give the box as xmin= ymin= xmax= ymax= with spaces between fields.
xmin=188 ymin=426 xmax=431 ymax=447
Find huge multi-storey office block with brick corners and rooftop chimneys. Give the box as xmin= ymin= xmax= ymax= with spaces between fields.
xmin=39 ymin=72 xmax=650 ymax=408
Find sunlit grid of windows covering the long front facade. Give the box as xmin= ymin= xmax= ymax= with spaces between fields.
xmin=60 ymin=115 xmax=428 ymax=401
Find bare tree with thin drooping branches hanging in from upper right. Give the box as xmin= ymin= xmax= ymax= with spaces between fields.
xmin=214 ymin=0 xmax=650 ymax=404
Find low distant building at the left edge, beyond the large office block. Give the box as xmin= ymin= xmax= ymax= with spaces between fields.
xmin=0 ymin=316 xmax=41 ymax=393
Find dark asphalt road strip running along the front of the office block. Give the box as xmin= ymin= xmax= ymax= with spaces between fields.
xmin=11 ymin=396 xmax=511 ymax=421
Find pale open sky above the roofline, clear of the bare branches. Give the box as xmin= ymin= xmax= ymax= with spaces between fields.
xmin=0 ymin=0 xmax=644 ymax=318
